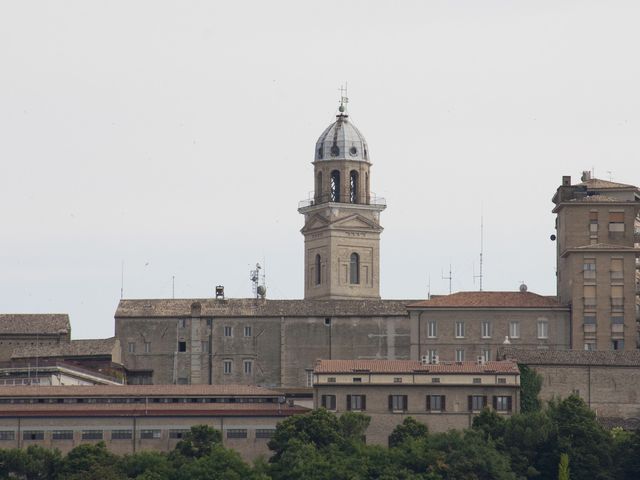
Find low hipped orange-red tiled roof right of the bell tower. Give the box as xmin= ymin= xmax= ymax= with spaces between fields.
xmin=408 ymin=292 xmax=567 ymax=308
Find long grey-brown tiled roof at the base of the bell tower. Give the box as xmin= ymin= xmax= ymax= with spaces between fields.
xmin=115 ymin=298 xmax=414 ymax=318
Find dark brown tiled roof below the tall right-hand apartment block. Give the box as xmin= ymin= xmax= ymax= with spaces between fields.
xmin=498 ymin=347 xmax=640 ymax=367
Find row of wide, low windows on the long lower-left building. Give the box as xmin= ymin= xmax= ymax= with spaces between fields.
xmin=0 ymin=428 xmax=276 ymax=441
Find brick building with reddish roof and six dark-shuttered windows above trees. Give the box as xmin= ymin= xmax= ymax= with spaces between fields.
xmin=314 ymin=359 xmax=520 ymax=444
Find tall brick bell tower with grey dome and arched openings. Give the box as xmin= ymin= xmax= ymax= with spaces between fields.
xmin=298 ymin=96 xmax=386 ymax=300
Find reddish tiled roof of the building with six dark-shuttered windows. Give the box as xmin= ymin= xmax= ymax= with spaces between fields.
xmin=314 ymin=360 xmax=519 ymax=374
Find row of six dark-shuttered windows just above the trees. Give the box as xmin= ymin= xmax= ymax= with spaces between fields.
xmin=320 ymin=395 xmax=513 ymax=413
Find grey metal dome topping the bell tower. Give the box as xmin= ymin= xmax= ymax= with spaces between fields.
xmin=315 ymin=105 xmax=369 ymax=162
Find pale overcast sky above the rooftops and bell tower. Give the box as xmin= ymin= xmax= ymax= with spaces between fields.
xmin=0 ymin=0 xmax=640 ymax=338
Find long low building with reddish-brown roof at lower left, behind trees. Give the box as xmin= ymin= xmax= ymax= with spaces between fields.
xmin=0 ymin=385 xmax=307 ymax=459
